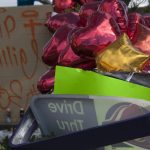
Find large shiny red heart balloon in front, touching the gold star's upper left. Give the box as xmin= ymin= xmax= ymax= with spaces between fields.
xmin=71 ymin=12 xmax=120 ymax=58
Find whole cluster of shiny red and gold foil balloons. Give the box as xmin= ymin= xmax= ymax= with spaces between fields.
xmin=37 ymin=0 xmax=150 ymax=93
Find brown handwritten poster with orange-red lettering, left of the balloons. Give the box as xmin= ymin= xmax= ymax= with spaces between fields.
xmin=0 ymin=5 xmax=52 ymax=123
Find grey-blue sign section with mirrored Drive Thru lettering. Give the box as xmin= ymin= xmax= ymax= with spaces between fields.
xmin=30 ymin=95 xmax=98 ymax=137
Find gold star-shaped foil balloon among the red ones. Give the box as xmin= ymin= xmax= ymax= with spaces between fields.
xmin=96 ymin=33 xmax=149 ymax=72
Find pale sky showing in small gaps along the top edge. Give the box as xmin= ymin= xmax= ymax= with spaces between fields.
xmin=0 ymin=0 xmax=148 ymax=7
